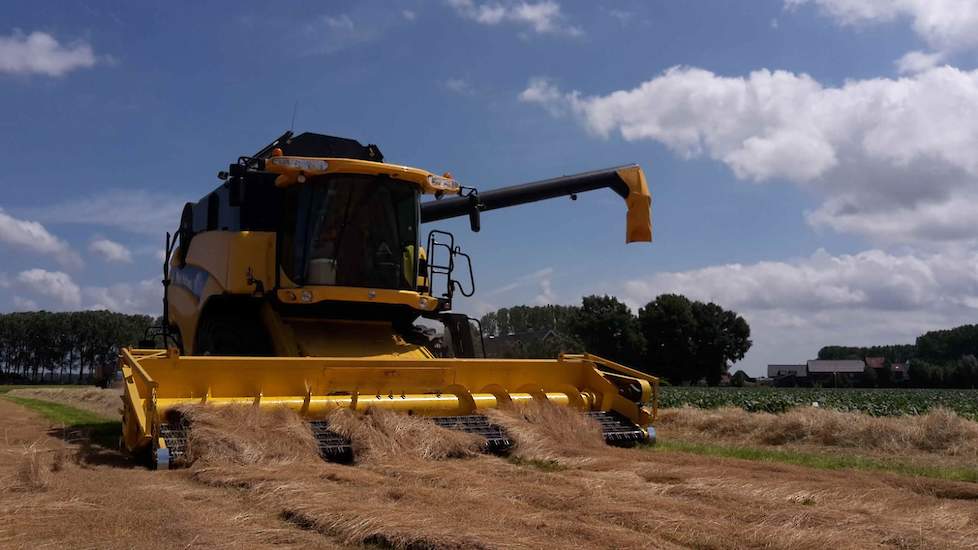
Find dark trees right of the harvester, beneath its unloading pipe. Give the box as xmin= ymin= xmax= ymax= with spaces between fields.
xmin=480 ymin=294 xmax=751 ymax=385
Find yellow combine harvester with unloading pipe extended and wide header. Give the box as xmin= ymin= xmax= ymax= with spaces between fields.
xmin=120 ymin=132 xmax=658 ymax=468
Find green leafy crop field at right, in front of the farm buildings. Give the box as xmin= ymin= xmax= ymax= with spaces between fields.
xmin=659 ymin=386 xmax=978 ymax=420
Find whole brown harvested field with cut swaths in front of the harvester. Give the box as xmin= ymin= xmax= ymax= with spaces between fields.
xmin=0 ymin=394 xmax=978 ymax=548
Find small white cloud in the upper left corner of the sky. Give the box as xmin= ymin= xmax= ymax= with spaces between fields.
xmin=0 ymin=30 xmax=96 ymax=76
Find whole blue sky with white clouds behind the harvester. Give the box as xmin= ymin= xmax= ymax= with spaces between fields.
xmin=0 ymin=0 xmax=978 ymax=374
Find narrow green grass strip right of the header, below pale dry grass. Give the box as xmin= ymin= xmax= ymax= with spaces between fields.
xmin=648 ymin=440 xmax=978 ymax=483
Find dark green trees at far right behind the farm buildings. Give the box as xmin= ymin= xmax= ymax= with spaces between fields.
xmin=818 ymin=325 xmax=978 ymax=388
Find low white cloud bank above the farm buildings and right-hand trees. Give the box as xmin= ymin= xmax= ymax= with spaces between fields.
xmin=618 ymin=248 xmax=978 ymax=374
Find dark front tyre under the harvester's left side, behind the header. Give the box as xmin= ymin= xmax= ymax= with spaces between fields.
xmin=194 ymin=308 xmax=271 ymax=356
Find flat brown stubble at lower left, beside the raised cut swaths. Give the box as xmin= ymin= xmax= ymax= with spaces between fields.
xmin=0 ymin=399 xmax=335 ymax=549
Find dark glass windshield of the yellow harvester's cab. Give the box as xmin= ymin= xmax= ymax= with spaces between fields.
xmin=281 ymin=174 xmax=419 ymax=290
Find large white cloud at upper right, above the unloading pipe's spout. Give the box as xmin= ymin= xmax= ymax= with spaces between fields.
xmin=520 ymin=66 xmax=978 ymax=242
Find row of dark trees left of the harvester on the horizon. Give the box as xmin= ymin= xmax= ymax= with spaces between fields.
xmin=0 ymin=311 xmax=153 ymax=383
